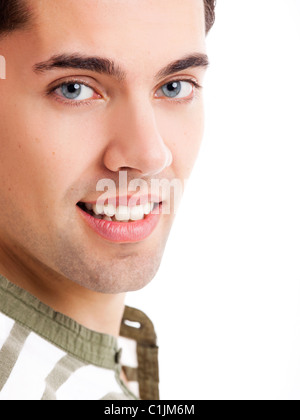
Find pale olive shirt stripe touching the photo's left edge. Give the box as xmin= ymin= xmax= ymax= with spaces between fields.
xmin=0 ymin=323 xmax=30 ymax=392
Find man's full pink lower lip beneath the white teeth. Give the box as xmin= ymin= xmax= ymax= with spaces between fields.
xmin=77 ymin=204 xmax=162 ymax=243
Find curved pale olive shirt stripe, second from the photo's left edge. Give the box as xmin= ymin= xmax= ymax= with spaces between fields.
xmin=42 ymin=355 xmax=87 ymax=401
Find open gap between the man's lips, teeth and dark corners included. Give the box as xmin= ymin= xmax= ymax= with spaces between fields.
xmin=77 ymin=202 xmax=161 ymax=223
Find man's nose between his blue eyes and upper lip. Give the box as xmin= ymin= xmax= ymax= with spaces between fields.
xmin=104 ymin=96 xmax=173 ymax=177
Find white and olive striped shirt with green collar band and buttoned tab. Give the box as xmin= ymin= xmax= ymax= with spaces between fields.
xmin=0 ymin=275 xmax=159 ymax=400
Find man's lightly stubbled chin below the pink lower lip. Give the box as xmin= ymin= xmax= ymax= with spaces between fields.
xmin=53 ymin=217 xmax=170 ymax=294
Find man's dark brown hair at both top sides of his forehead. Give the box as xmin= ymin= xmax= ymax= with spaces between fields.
xmin=0 ymin=0 xmax=216 ymax=34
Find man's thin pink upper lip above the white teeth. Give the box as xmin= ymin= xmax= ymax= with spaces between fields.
xmin=80 ymin=193 xmax=164 ymax=207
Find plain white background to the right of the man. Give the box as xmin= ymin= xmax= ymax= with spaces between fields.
xmin=127 ymin=0 xmax=300 ymax=400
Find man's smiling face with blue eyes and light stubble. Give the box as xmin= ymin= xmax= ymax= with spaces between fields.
xmin=0 ymin=0 xmax=205 ymax=293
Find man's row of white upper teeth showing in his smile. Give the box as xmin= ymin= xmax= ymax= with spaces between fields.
xmin=89 ymin=203 xmax=155 ymax=222
